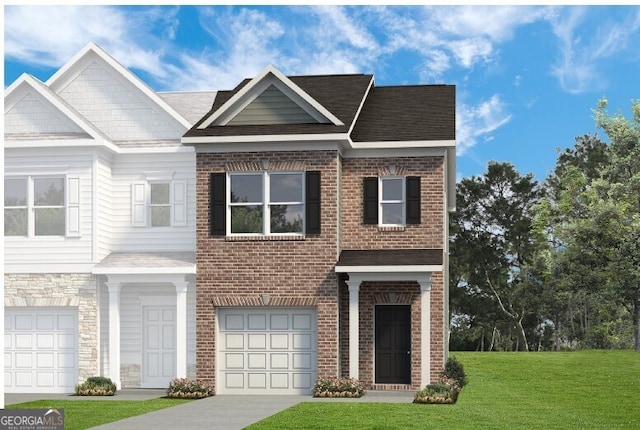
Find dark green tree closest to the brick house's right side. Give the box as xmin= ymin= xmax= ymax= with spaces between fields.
xmin=451 ymin=162 xmax=543 ymax=350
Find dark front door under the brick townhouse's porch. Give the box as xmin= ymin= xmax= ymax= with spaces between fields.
xmin=376 ymin=305 xmax=411 ymax=384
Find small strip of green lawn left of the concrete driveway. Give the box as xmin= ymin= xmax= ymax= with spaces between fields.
xmin=6 ymin=397 xmax=192 ymax=430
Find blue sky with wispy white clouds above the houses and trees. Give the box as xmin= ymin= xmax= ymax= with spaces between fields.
xmin=4 ymin=3 xmax=640 ymax=181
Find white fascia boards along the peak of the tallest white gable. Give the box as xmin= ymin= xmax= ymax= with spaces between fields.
xmin=46 ymin=42 xmax=193 ymax=130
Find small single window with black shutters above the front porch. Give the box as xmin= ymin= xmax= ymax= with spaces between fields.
xmin=362 ymin=176 xmax=421 ymax=226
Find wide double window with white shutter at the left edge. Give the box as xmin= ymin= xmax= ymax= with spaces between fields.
xmin=4 ymin=176 xmax=74 ymax=237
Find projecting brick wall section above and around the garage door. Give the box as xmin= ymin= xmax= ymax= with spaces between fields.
xmin=196 ymin=151 xmax=338 ymax=386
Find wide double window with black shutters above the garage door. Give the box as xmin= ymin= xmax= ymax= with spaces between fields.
xmin=210 ymin=171 xmax=320 ymax=236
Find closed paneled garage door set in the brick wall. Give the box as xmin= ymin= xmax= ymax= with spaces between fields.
xmin=217 ymin=308 xmax=318 ymax=394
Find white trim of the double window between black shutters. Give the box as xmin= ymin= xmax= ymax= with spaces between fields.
xmin=226 ymin=170 xmax=306 ymax=237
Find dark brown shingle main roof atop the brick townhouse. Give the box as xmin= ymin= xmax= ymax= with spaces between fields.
xmin=185 ymin=74 xmax=455 ymax=142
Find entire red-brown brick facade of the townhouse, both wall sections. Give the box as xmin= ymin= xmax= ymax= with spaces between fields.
xmin=196 ymin=151 xmax=445 ymax=389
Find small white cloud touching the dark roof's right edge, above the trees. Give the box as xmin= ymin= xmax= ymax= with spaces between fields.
xmin=456 ymin=94 xmax=511 ymax=156
